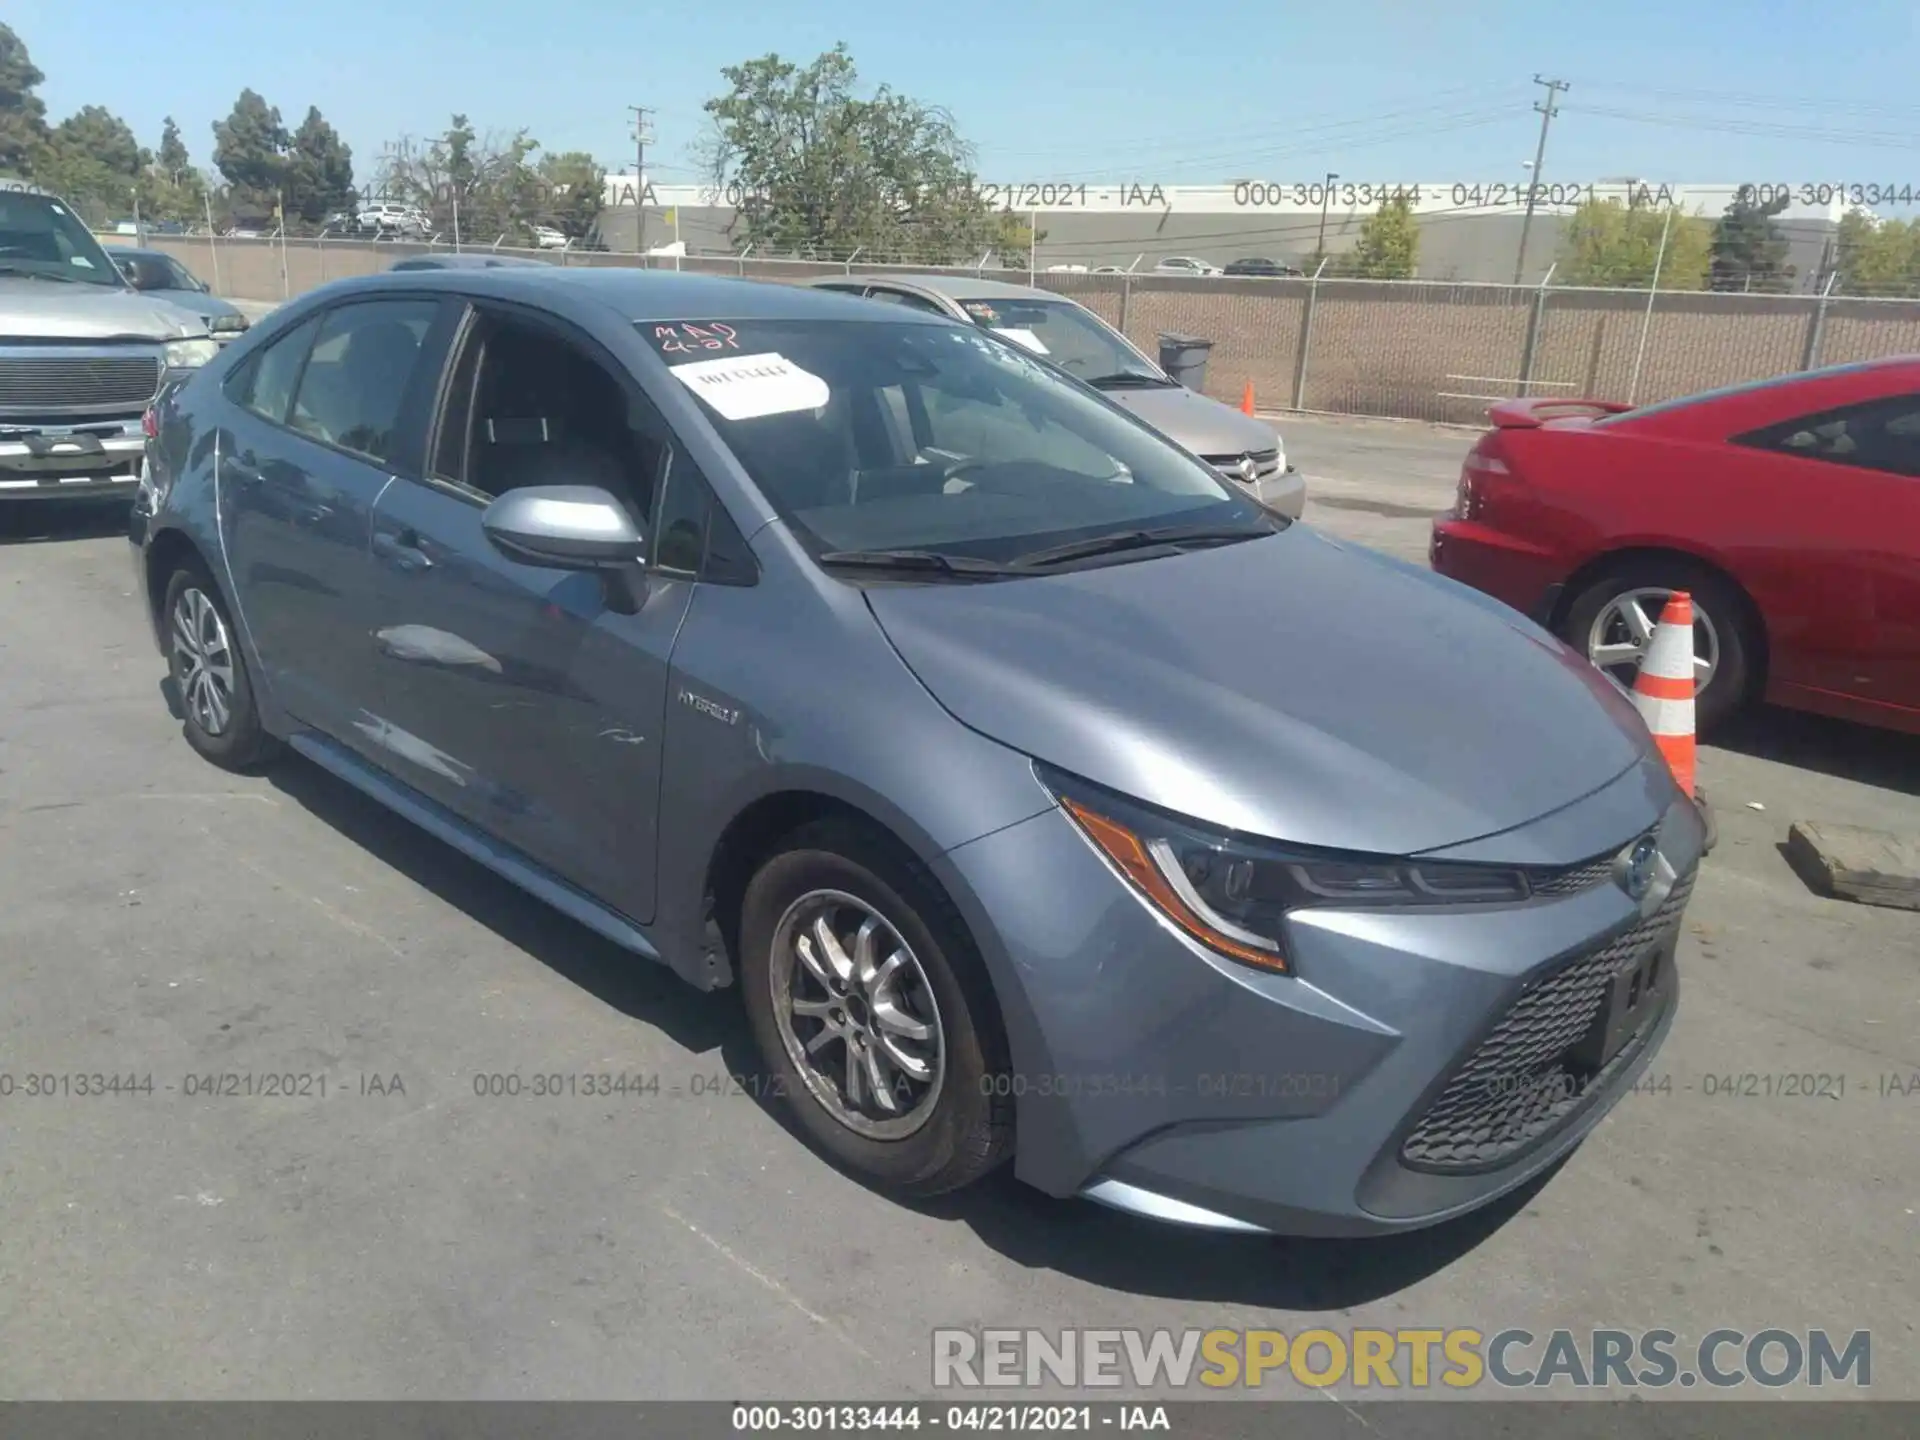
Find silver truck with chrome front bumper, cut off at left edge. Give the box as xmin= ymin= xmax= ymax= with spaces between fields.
xmin=0 ymin=179 xmax=219 ymax=505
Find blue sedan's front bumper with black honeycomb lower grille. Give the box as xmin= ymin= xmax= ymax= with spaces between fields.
xmin=941 ymin=766 xmax=1703 ymax=1235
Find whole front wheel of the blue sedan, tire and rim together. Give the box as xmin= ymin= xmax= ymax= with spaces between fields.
xmin=739 ymin=822 xmax=1014 ymax=1196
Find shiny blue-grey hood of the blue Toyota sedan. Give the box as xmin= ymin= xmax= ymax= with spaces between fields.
xmin=868 ymin=524 xmax=1649 ymax=858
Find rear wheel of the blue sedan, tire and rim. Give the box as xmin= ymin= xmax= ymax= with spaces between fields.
xmin=163 ymin=564 xmax=280 ymax=770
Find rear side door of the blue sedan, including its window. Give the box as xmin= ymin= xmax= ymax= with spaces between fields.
xmin=219 ymin=296 xmax=445 ymax=749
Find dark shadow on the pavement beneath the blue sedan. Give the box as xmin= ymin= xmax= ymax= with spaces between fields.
xmin=267 ymin=756 xmax=1557 ymax=1311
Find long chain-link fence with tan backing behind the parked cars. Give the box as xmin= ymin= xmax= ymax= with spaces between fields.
xmin=127 ymin=236 xmax=1920 ymax=424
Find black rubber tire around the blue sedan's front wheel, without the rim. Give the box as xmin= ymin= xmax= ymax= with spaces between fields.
xmin=739 ymin=820 xmax=1014 ymax=1196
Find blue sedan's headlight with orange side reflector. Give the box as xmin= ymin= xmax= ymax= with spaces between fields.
xmin=1035 ymin=766 xmax=1532 ymax=973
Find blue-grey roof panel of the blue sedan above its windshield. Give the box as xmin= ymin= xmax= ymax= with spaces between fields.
xmin=326 ymin=263 xmax=945 ymax=324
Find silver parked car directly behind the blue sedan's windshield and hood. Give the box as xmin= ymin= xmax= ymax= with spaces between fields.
xmin=812 ymin=275 xmax=1306 ymax=518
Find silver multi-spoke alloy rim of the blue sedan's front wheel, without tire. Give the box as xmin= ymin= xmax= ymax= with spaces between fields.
xmin=768 ymin=891 xmax=947 ymax=1140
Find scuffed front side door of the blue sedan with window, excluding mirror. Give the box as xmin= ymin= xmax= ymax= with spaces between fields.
xmin=360 ymin=301 xmax=693 ymax=924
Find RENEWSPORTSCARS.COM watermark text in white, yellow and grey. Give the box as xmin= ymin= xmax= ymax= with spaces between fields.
xmin=933 ymin=1329 xmax=1874 ymax=1390
